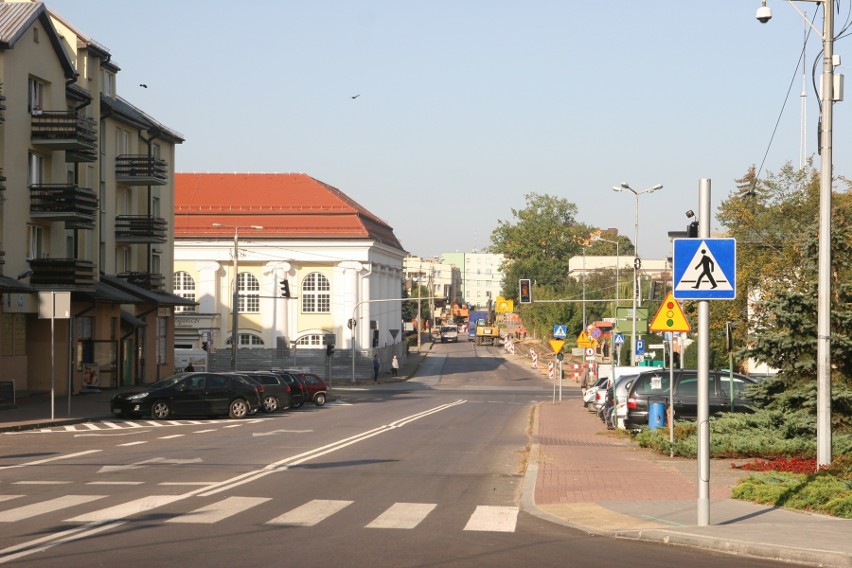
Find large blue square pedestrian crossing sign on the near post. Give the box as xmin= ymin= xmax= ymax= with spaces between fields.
xmin=672 ymin=239 xmax=737 ymax=300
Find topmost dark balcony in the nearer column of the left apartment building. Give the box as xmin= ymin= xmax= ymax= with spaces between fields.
xmin=32 ymin=111 xmax=98 ymax=162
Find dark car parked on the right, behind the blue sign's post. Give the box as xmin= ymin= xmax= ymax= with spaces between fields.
xmin=624 ymin=369 xmax=757 ymax=429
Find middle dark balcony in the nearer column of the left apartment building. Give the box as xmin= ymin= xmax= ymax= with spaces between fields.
xmin=30 ymin=183 xmax=98 ymax=229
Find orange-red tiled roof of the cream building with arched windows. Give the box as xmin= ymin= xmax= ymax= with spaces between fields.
xmin=175 ymin=173 xmax=402 ymax=249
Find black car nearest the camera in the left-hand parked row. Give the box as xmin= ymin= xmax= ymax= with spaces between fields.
xmin=109 ymin=373 xmax=263 ymax=420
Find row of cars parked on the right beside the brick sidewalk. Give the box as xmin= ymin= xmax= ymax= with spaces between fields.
xmin=583 ymin=368 xmax=757 ymax=430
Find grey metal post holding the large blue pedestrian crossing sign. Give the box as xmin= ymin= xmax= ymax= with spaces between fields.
xmin=700 ymin=179 xmax=712 ymax=526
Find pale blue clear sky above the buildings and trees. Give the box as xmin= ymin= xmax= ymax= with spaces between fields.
xmin=47 ymin=0 xmax=852 ymax=258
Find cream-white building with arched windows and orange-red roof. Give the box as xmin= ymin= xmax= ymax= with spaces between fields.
xmin=174 ymin=173 xmax=406 ymax=378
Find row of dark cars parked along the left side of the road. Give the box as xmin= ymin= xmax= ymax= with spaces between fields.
xmin=110 ymin=369 xmax=328 ymax=420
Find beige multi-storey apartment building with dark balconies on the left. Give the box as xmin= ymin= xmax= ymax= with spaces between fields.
xmin=0 ymin=0 xmax=189 ymax=395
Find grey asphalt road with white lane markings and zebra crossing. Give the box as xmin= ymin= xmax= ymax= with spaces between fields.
xmin=0 ymin=342 xmax=792 ymax=568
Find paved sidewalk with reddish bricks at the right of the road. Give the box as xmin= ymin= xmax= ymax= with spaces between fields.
xmin=523 ymin=385 xmax=852 ymax=567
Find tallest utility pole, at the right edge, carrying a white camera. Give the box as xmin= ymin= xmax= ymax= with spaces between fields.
xmin=817 ymin=0 xmax=834 ymax=467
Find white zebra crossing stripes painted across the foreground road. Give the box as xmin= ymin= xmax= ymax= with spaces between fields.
xmin=0 ymin=495 xmax=518 ymax=532
